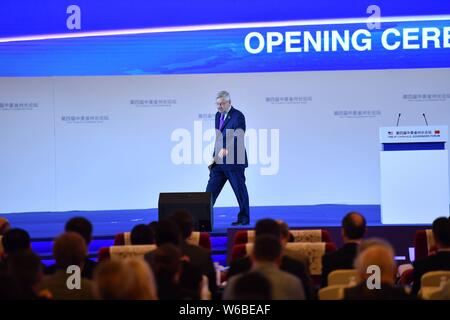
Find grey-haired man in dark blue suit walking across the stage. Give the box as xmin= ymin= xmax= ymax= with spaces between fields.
xmin=206 ymin=91 xmax=250 ymax=226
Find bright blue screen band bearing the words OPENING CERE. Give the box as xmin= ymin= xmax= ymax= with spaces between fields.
xmin=0 ymin=18 xmax=450 ymax=76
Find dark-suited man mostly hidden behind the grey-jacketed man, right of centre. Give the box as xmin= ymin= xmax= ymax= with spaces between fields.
xmin=227 ymin=219 xmax=316 ymax=300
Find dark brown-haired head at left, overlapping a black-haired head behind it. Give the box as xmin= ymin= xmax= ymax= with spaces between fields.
xmin=53 ymin=231 xmax=87 ymax=270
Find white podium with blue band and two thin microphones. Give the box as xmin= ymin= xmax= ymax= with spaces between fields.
xmin=380 ymin=126 xmax=449 ymax=224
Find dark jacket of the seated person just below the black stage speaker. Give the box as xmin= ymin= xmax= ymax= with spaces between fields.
xmin=181 ymin=243 xmax=217 ymax=297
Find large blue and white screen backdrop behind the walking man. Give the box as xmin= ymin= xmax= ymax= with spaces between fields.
xmin=0 ymin=0 xmax=450 ymax=213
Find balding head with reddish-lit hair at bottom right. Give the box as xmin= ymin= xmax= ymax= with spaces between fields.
xmin=355 ymin=245 xmax=397 ymax=285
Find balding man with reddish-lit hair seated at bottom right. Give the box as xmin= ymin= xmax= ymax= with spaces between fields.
xmin=344 ymin=244 xmax=414 ymax=300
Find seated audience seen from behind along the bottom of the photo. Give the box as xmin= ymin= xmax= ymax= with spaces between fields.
xmin=0 ymin=211 xmax=450 ymax=300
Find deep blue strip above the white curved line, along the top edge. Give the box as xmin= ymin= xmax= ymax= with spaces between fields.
xmin=0 ymin=0 xmax=450 ymax=37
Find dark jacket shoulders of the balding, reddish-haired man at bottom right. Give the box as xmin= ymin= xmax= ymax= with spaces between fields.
xmin=344 ymin=282 xmax=415 ymax=300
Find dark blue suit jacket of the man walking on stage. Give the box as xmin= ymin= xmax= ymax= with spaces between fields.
xmin=213 ymin=107 xmax=248 ymax=170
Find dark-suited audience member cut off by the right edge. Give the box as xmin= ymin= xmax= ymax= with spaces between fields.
xmin=412 ymin=217 xmax=450 ymax=294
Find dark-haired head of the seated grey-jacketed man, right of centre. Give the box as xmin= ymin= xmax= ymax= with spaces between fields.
xmin=252 ymin=234 xmax=282 ymax=265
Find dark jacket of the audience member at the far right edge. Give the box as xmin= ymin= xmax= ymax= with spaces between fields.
xmin=412 ymin=251 xmax=450 ymax=294
